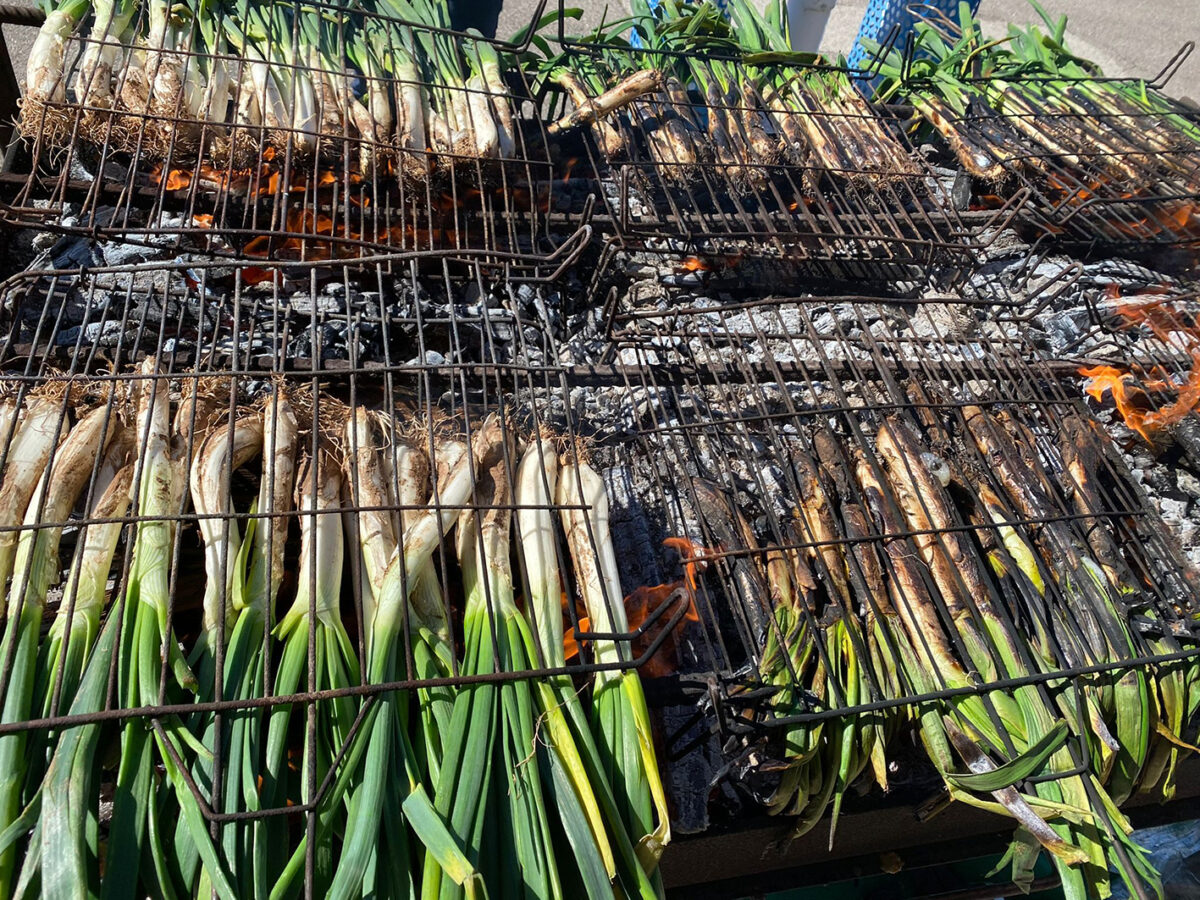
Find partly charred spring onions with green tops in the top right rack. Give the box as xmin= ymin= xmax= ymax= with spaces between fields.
xmin=871 ymin=0 xmax=1200 ymax=194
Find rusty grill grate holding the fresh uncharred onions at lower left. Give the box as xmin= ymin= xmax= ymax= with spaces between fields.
xmin=0 ymin=303 xmax=686 ymax=895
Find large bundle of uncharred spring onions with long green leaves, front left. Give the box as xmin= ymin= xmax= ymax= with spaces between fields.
xmin=0 ymin=367 xmax=670 ymax=898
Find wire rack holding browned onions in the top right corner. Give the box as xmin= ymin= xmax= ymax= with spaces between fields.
xmin=881 ymin=31 xmax=1200 ymax=255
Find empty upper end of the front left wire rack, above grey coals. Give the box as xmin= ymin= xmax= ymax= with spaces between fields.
xmin=0 ymin=226 xmax=590 ymax=374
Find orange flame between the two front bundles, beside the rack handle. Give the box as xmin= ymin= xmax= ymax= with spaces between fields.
xmin=563 ymin=538 xmax=709 ymax=678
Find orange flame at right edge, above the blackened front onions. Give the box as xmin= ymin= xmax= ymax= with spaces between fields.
xmin=1079 ymin=297 xmax=1200 ymax=444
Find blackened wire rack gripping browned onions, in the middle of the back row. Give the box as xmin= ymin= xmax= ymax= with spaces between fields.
xmin=547 ymin=44 xmax=1024 ymax=289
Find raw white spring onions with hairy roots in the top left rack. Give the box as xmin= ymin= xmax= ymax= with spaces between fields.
xmin=20 ymin=0 xmax=520 ymax=179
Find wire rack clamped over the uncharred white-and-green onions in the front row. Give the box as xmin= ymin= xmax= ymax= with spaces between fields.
xmin=0 ymin=301 xmax=686 ymax=895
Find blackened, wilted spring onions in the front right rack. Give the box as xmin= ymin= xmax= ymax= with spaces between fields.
xmin=710 ymin=403 xmax=1200 ymax=898
